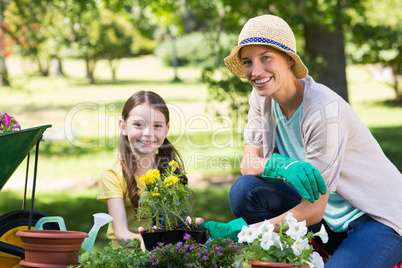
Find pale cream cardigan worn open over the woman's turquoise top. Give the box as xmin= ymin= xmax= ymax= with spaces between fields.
xmin=244 ymin=76 xmax=402 ymax=236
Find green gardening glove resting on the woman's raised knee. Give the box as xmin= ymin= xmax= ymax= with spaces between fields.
xmin=262 ymin=154 xmax=327 ymax=203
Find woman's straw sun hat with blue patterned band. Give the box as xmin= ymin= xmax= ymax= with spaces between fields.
xmin=225 ymin=15 xmax=308 ymax=79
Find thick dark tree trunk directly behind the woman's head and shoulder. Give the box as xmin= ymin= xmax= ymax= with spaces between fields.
xmin=304 ymin=24 xmax=349 ymax=102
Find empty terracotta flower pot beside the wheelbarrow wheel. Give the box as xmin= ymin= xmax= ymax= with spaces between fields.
xmin=17 ymin=230 xmax=88 ymax=268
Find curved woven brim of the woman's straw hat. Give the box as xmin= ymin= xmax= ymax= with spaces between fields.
xmin=224 ymin=43 xmax=308 ymax=79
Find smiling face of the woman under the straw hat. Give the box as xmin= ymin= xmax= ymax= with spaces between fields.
xmin=240 ymin=45 xmax=294 ymax=96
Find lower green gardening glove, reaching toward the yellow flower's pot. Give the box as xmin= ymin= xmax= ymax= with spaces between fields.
xmin=200 ymin=218 xmax=248 ymax=242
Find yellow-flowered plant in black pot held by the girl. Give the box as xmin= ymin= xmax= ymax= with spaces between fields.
xmin=137 ymin=160 xmax=206 ymax=250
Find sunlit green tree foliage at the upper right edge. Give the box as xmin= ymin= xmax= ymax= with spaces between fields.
xmin=348 ymin=0 xmax=402 ymax=103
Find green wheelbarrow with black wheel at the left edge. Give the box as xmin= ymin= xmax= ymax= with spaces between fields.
xmin=0 ymin=125 xmax=55 ymax=267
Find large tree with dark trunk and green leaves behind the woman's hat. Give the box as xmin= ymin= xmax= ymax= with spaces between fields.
xmin=184 ymin=0 xmax=370 ymax=124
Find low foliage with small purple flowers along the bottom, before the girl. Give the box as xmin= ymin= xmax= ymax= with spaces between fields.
xmin=79 ymin=233 xmax=240 ymax=268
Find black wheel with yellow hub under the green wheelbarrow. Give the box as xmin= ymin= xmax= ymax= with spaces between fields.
xmin=0 ymin=210 xmax=57 ymax=268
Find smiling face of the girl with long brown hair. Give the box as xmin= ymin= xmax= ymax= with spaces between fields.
xmin=119 ymin=103 xmax=169 ymax=155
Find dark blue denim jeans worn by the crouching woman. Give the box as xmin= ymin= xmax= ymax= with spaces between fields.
xmin=229 ymin=175 xmax=402 ymax=268
